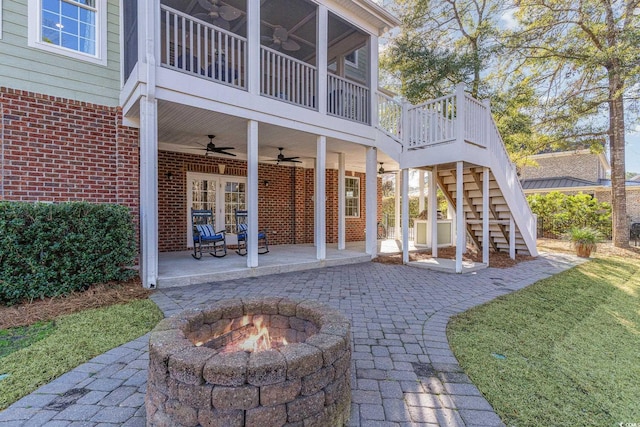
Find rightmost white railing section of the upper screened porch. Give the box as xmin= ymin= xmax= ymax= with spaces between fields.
xmin=327 ymin=74 xmax=371 ymax=124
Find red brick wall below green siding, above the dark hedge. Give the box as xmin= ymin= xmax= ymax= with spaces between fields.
xmin=0 ymin=87 xmax=139 ymax=225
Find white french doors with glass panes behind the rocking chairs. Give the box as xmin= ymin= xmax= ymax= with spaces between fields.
xmin=187 ymin=172 xmax=247 ymax=247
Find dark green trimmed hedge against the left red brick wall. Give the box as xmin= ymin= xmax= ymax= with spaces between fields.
xmin=0 ymin=202 xmax=136 ymax=305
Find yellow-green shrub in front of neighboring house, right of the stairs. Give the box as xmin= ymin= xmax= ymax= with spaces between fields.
xmin=527 ymin=191 xmax=611 ymax=238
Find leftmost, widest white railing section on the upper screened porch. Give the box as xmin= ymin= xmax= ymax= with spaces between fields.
xmin=160 ymin=5 xmax=247 ymax=89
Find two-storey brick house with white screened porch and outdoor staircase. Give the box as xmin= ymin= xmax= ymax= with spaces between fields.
xmin=0 ymin=0 xmax=536 ymax=287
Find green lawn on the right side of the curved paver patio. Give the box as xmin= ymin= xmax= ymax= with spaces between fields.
xmin=447 ymin=257 xmax=640 ymax=426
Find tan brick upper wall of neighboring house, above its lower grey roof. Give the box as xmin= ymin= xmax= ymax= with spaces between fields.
xmin=520 ymin=153 xmax=604 ymax=182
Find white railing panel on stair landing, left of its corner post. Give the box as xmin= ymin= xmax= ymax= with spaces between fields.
xmin=405 ymin=95 xmax=456 ymax=148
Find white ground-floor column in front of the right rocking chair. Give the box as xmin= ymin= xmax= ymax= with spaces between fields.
xmin=247 ymin=120 xmax=258 ymax=268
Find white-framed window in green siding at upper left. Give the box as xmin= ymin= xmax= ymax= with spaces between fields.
xmin=29 ymin=0 xmax=107 ymax=65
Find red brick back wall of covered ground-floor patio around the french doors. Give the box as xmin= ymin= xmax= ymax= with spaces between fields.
xmin=158 ymin=151 xmax=382 ymax=251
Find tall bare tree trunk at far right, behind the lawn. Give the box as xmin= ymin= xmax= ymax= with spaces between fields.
xmin=609 ymin=70 xmax=629 ymax=248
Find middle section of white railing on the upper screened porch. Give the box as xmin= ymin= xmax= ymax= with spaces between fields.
xmin=260 ymin=46 xmax=317 ymax=109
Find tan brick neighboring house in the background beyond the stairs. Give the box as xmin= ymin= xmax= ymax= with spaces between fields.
xmin=520 ymin=150 xmax=640 ymax=223
